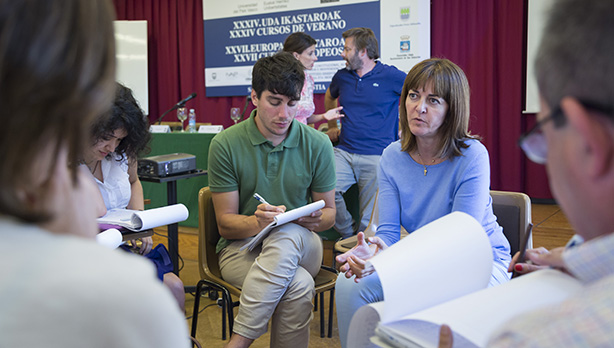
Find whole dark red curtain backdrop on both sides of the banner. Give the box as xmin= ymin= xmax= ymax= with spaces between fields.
xmin=114 ymin=0 xmax=551 ymax=198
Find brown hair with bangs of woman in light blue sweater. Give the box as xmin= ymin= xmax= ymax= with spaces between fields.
xmin=399 ymin=58 xmax=479 ymax=158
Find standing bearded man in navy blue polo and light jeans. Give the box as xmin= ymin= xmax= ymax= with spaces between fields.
xmin=324 ymin=28 xmax=406 ymax=238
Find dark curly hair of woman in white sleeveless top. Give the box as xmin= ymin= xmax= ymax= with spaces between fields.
xmin=92 ymin=83 xmax=151 ymax=160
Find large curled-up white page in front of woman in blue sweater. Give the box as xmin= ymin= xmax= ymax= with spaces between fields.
xmin=370 ymin=212 xmax=493 ymax=323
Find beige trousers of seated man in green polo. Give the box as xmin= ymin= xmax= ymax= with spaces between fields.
xmin=219 ymin=223 xmax=322 ymax=348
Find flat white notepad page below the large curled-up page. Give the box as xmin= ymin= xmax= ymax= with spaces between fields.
xmin=380 ymin=269 xmax=582 ymax=347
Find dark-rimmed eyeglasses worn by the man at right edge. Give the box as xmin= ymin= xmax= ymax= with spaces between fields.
xmin=518 ymin=101 xmax=612 ymax=164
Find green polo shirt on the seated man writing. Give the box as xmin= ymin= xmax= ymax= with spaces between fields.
xmin=208 ymin=110 xmax=336 ymax=252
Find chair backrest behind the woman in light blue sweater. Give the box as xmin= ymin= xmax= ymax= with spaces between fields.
xmin=490 ymin=191 xmax=533 ymax=256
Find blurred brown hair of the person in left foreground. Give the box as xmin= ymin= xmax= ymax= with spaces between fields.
xmin=0 ymin=0 xmax=115 ymax=222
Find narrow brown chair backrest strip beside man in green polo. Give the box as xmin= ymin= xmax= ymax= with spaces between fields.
xmin=198 ymin=186 xmax=222 ymax=279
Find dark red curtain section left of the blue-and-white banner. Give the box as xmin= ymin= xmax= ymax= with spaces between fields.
xmin=113 ymin=0 xmax=252 ymax=126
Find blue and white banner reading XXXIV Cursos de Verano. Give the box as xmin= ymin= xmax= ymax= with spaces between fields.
xmin=203 ymin=0 xmax=430 ymax=97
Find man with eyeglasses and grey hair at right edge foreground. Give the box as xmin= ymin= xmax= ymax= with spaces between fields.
xmin=439 ymin=0 xmax=614 ymax=348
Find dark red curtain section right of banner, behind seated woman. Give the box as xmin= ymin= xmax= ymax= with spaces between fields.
xmin=431 ymin=0 xmax=552 ymax=198
